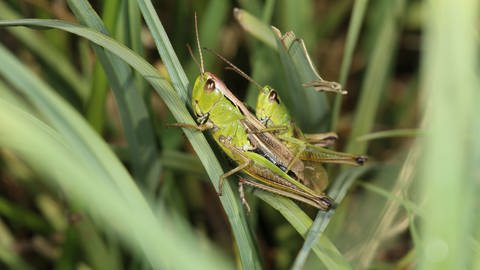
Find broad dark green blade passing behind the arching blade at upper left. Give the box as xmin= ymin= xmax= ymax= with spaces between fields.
xmin=68 ymin=0 xmax=160 ymax=188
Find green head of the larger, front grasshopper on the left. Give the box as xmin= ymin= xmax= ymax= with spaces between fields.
xmin=192 ymin=72 xmax=226 ymax=117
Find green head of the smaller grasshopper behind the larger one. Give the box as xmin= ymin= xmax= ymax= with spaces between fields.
xmin=256 ymin=85 xmax=289 ymax=126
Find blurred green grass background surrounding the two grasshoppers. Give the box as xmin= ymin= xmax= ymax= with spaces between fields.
xmin=0 ymin=0 xmax=480 ymax=269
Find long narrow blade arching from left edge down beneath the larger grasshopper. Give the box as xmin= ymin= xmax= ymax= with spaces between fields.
xmin=0 ymin=19 xmax=260 ymax=269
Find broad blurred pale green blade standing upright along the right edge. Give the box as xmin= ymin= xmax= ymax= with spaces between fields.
xmin=418 ymin=1 xmax=480 ymax=270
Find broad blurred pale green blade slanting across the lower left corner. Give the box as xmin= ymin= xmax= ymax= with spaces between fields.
xmin=0 ymin=99 xmax=232 ymax=269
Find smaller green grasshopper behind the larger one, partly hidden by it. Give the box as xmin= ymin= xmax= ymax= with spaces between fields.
xmin=208 ymin=50 xmax=367 ymax=191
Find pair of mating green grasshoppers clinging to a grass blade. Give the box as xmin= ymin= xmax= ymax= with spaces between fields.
xmin=176 ymin=16 xmax=366 ymax=210
